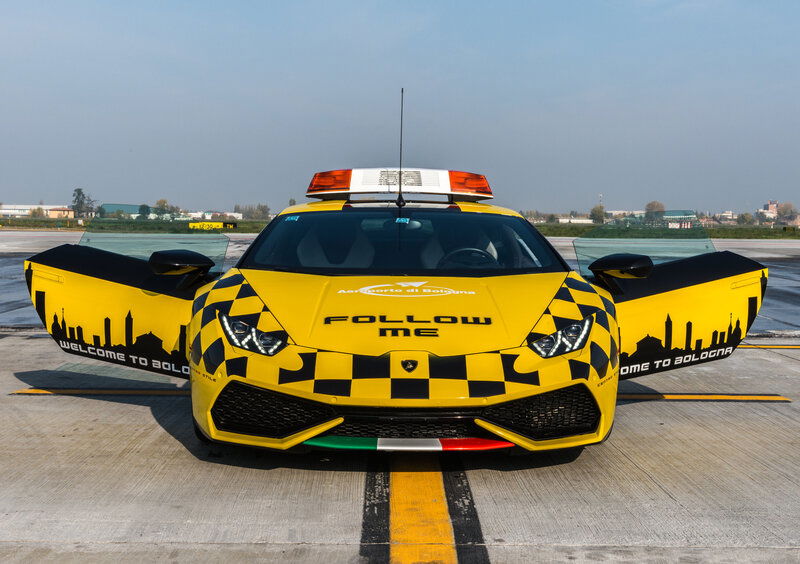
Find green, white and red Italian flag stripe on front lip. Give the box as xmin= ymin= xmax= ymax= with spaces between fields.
xmin=303 ymin=435 xmax=514 ymax=451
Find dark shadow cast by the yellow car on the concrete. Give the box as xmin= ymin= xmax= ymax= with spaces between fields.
xmin=14 ymin=369 xmax=640 ymax=472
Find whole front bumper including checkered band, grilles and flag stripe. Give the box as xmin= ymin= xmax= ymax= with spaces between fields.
xmin=190 ymin=290 xmax=619 ymax=451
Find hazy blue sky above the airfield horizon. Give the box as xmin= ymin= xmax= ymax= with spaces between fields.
xmin=0 ymin=0 xmax=800 ymax=211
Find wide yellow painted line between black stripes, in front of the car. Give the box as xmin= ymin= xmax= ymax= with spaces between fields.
xmin=389 ymin=455 xmax=458 ymax=564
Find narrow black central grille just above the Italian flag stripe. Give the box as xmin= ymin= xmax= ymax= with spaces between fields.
xmin=328 ymin=417 xmax=485 ymax=439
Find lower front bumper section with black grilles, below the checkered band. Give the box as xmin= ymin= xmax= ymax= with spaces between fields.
xmin=195 ymin=378 xmax=616 ymax=450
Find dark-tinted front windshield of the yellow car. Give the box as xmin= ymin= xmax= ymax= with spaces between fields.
xmin=239 ymin=207 xmax=567 ymax=276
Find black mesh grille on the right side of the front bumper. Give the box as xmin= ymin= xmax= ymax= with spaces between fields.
xmin=483 ymin=384 xmax=600 ymax=441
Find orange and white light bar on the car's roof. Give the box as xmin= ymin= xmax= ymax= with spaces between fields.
xmin=306 ymin=168 xmax=492 ymax=200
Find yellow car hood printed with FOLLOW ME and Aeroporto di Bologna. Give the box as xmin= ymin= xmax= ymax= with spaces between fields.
xmin=241 ymin=270 xmax=567 ymax=356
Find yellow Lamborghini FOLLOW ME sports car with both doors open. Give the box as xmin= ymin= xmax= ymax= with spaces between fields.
xmin=25 ymin=168 xmax=767 ymax=451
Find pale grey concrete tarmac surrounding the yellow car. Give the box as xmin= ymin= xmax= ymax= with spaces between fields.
xmin=0 ymin=229 xmax=800 ymax=564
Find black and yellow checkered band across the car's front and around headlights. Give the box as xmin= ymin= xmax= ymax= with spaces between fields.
xmin=190 ymin=269 xmax=618 ymax=405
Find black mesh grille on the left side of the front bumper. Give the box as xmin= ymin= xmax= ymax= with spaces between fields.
xmin=211 ymin=381 xmax=336 ymax=439
